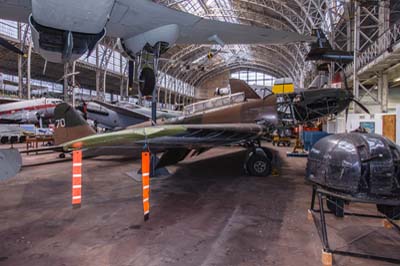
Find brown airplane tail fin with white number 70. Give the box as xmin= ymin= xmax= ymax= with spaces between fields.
xmin=54 ymin=103 xmax=96 ymax=145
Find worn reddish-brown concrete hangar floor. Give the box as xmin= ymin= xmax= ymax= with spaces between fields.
xmin=0 ymin=144 xmax=400 ymax=266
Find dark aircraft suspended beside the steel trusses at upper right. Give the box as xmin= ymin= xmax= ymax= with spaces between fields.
xmin=306 ymin=29 xmax=354 ymax=63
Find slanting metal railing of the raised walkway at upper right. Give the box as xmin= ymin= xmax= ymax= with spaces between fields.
xmin=345 ymin=24 xmax=400 ymax=76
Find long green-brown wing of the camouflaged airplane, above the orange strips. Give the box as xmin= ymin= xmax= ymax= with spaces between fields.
xmin=63 ymin=124 xmax=265 ymax=152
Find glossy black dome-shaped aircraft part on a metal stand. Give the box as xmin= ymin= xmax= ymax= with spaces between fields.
xmin=306 ymin=133 xmax=400 ymax=206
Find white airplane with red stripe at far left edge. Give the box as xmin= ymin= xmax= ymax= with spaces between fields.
xmin=0 ymin=98 xmax=62 ymax=124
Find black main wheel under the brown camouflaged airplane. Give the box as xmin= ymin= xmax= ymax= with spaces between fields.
xmin=244 ymin=143 xmax=272 ymax=176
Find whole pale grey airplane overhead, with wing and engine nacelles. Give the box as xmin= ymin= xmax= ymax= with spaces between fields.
xmin=0 ymin=0 xmax=315 ymax=63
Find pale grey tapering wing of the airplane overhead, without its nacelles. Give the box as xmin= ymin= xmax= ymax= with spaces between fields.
xmin=107 ymin=0 xmax=315 ymax=44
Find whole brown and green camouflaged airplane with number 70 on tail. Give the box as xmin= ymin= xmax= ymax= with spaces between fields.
xmin=51 ymin=82 xmax=354 ymax=176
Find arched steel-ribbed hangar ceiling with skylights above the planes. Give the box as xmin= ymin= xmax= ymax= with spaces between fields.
xmin=155 ymin=0 xmax=343 ymax=86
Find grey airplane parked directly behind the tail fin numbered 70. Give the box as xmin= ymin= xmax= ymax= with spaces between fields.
xmin=78 ymin=101 xmax=180 ymax=130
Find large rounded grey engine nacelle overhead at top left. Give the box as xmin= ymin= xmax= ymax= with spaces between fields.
xmin=29 ymin=0 xmax=115 ymax=63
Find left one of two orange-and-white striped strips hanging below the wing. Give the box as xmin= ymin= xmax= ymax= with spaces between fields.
xmin=72 ymin=150 xmax=82 ymax=209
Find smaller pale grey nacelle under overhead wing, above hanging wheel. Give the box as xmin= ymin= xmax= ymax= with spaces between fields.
xmin=121 ymin=24 xmax=179 ymax=58
